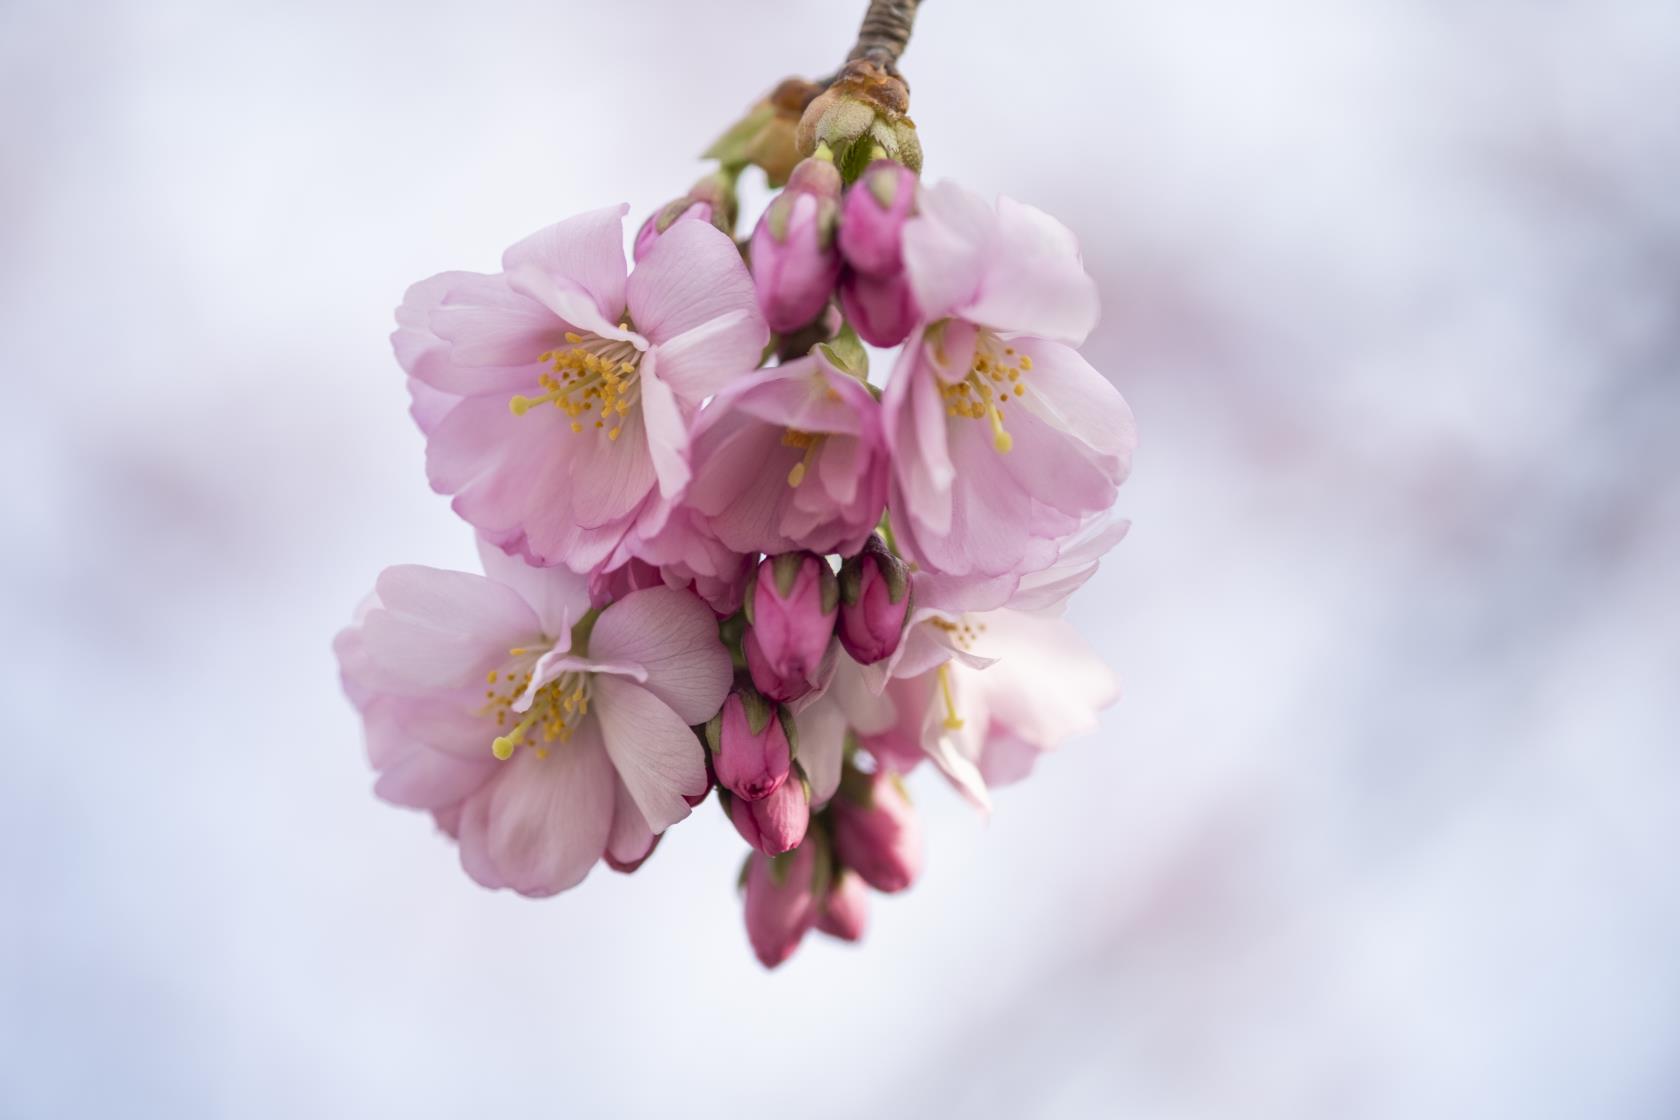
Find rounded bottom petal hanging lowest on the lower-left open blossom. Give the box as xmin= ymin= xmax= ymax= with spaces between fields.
xmin=486 ymin=720 xmax=613 ymax=897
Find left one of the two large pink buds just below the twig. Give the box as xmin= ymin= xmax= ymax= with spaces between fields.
xmin=751 ymin=158 xmax=840 ymax=334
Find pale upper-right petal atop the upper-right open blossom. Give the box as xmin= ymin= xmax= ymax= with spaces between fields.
xmin=963 ymin=198 xmax=1100 ymax=346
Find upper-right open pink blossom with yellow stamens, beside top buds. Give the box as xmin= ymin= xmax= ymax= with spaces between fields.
xmin=882 ymin=183 xmax=1136 ymax=579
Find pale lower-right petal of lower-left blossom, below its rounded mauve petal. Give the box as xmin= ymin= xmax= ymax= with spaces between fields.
xmin=590 ymin=677 xmax=706 ymax=833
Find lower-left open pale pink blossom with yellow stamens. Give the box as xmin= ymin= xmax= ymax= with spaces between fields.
xmin=334 ymin=547 xmax=731 ymax=895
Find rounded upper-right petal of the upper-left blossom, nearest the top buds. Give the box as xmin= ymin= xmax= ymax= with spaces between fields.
xmin=627 ymin=222 xmax=769 ymax=352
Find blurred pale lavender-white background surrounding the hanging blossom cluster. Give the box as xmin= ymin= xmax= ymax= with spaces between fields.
xmin=0 ymin=0 xmax=1680 ymax=1120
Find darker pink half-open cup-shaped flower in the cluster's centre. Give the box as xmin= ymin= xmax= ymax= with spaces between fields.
xmin=684 ymin=353 xmax=887 ymax=554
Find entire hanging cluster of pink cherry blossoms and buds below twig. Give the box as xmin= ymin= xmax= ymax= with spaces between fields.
xmin=336 ymin=74 xmax=1134 ymax=967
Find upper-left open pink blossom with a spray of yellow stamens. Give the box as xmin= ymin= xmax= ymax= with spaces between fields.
xmin=393 ymin=207 xmax=768 ymax=571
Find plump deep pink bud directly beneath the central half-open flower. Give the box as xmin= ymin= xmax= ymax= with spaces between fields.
xmin=743 ymin=552 xmax=840 ymax=704
